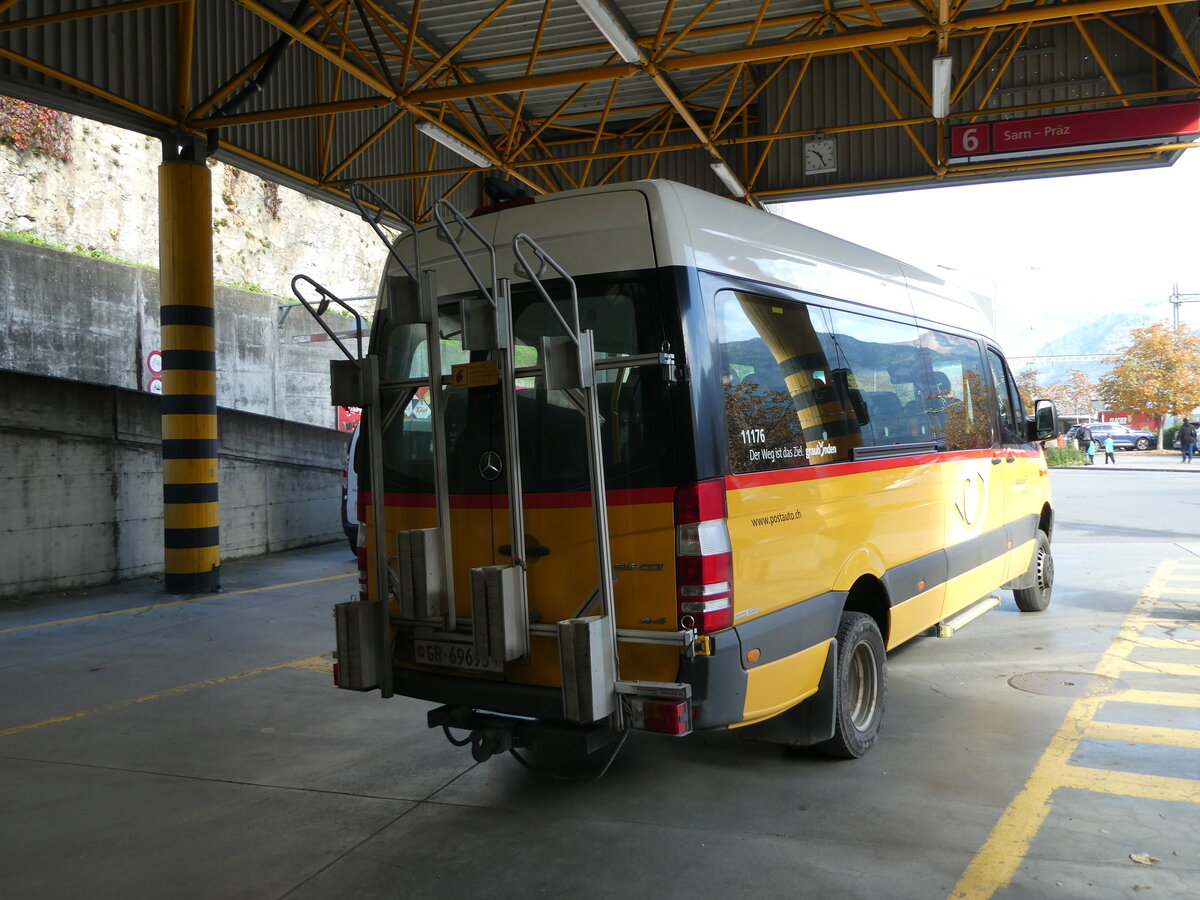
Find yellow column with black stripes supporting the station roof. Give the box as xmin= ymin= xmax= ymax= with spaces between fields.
xmin=158 ymin=152 xmax=221 ymax=594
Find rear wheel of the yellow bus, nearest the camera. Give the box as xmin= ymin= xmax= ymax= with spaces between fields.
xmin=817 ymin=612 xmax=888 ymax=760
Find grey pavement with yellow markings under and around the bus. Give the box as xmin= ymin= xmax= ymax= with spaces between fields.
xmin=0 ymin=475 xmax=1200 ymax=900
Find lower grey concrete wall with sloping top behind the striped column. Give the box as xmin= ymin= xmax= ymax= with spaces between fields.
xmin=0 ymin=369 xmax=348 ymax=598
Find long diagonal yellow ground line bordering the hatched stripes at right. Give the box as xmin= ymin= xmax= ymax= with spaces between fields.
xmin=949 ymin=560 xmax=1176 ymax=900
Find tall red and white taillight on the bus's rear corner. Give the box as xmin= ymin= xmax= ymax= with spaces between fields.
xmin=674 ymin=479 xmax=733 ymax=634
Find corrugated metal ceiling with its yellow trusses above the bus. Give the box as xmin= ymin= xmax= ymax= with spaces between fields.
xmin=0 ymin=0 xmax=1200 ymax=217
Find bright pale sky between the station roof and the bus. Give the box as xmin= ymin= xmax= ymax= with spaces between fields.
xmin=778 ymin=150 xmax=1200 ymax=356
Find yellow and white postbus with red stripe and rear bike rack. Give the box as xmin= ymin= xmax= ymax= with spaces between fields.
xmin=328 ymin=181 xmax=1057 ymax=772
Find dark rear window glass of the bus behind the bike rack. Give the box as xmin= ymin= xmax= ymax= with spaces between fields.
xmin=377 ymin=272 xmax=672 ymax=493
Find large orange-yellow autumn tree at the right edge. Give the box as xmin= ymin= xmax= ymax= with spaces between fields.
xmin=1099 ymin=322 xmax=1200 ymax=450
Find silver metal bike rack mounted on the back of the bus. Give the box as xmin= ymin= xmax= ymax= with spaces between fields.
xmin=304 ymin=184 xmax=696 ymax=732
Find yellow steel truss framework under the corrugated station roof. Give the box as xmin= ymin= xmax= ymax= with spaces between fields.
xmin=0 ymin=0 xmax=1200 ymax=217
